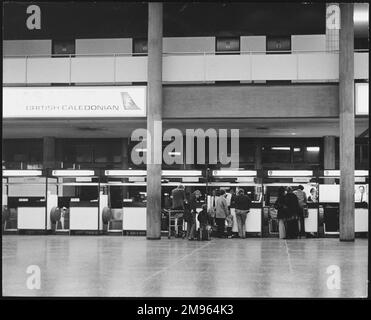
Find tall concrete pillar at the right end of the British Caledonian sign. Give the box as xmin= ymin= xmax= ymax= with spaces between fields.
xmin=147 ymin=2 xmax=162 ymax=240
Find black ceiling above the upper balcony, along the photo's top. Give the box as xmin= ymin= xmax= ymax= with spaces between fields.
xmin=3 ymin=1 xmax=368 ymax=40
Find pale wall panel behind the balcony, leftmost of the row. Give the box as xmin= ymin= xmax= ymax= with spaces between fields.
xmin=3 ymin=40 xmax=52 ymax=56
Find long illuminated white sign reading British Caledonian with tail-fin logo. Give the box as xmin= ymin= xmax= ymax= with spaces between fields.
xmin=3 ymin=86 xmax=147 ymax=118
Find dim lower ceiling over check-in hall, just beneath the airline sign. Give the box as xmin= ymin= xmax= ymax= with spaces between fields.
xmin=3 ymin=117 xmax=368 ymax=139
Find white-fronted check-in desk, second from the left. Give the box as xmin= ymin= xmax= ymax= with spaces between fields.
xmin=70 ymin=201 xmax=99 ymax=230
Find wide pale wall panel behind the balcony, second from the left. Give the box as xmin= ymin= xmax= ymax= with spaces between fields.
xmin=76 ymin=38 xmax=133 ymax=55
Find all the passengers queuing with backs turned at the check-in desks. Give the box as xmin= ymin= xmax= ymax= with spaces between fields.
xmin=171 ymin=185 xmax=313 ymax=240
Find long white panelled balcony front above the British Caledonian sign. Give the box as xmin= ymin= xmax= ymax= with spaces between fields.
xmin=3 ymin=50 xmax=369 ymax=85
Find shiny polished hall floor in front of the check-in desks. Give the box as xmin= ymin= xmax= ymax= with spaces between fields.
xmin=2 ymin=235 xmax=368 ymax=297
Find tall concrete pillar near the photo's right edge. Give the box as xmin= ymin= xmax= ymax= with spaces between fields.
xmin=339 ymin=3 xmax=355 ymax=241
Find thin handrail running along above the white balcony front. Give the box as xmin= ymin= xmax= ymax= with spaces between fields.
xmin=3 ymin=49 xmax=369 ymax=59
